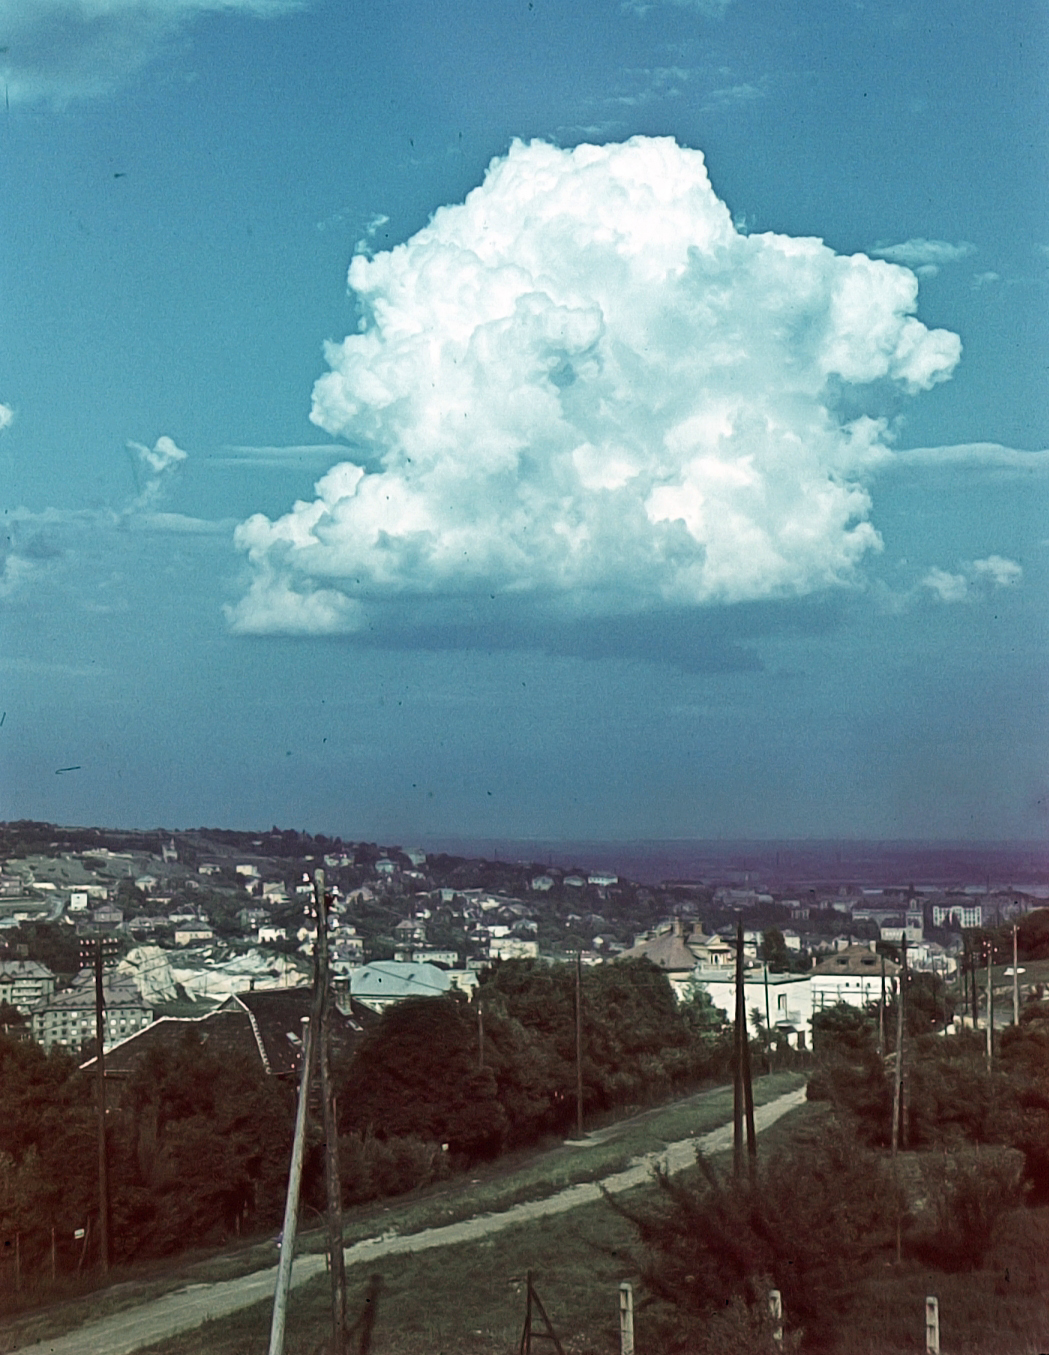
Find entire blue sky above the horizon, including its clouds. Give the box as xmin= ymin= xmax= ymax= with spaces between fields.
xmin=0 ymin=0 xmax=1049 ymax=841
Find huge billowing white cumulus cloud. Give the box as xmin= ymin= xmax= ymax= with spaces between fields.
xmin=230 ymin=137 xmax=961 ymax=631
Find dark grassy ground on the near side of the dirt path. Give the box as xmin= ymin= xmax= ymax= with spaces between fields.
xmin=135 ymin=1104 xmax=1049 ymax=1355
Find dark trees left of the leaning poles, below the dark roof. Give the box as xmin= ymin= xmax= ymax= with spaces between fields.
xmin=0 ymin=1035 xmax=294 ymax=1270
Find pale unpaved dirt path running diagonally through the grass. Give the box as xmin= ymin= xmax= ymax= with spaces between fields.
xmin=16 ymin=1087 xmax=805 ymax=1355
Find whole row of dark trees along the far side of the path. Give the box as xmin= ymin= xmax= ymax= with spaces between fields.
xmin=0 ymin=961 xmax=732 ymax=1274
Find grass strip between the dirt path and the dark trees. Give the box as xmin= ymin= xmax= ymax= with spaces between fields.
xmin=0 ymin=1073 xmax=805 ymax=1355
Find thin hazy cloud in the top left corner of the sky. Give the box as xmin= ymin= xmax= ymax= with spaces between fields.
xmin=0 ymin=0 xmax=305 ymax=103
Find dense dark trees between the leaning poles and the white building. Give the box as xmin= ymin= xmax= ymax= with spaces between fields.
xmin=340 ymin=961 xmax=725 ymax=1159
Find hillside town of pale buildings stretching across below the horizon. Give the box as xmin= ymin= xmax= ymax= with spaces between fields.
xmin=0 ymin=840 xmax=1045 ymax=1051
